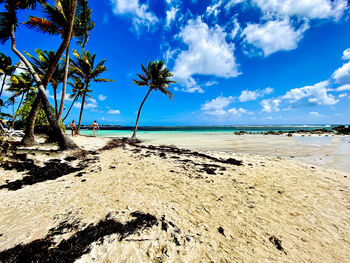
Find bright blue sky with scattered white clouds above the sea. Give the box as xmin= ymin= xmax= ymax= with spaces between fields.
xmin=0 ymin=0 xmax=350 ymax=126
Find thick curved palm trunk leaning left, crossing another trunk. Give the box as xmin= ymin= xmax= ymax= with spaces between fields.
xmin=11 ymin=11 xmax=77 ymax=150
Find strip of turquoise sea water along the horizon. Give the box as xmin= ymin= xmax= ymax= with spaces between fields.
xmin=67 ymin=125 xmax=335 ymax=137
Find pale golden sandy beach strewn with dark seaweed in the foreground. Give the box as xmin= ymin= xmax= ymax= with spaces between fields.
xmin=0 ymin=136 xmax=350 ymax=262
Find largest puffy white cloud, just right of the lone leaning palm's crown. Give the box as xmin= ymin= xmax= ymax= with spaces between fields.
xmin=173 ymin=18 xmax=240 ymax=92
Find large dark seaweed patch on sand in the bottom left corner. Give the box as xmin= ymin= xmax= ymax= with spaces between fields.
xmin=0 ymin=211 xmax=157 ymax=263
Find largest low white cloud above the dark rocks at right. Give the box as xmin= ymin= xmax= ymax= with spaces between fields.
xmin=282 ymin=81 xmax=339 ymax=106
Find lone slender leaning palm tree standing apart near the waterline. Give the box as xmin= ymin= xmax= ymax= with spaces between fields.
xmin=131 ymin=60 xmax=176 ymax=139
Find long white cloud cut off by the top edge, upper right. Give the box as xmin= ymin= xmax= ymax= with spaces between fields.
xmin=253 ymin=0 xmax=347 ymax=20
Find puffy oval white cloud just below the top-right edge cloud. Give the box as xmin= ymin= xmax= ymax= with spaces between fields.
xmin=241 ymin=19 xmax=309 ymax=57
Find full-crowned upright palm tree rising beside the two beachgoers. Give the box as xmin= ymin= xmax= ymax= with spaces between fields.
xmin=70 ymin=49 xmax=113 ymax=134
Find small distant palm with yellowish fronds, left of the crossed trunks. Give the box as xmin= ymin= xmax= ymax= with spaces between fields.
xmin=8 ymin=73 xmax=36 ymax=122
